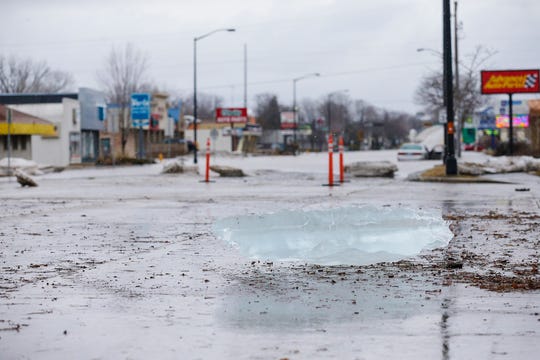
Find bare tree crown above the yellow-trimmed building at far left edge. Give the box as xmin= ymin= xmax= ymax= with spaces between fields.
xmin=0 ymin=55 xmax=74 ymax=93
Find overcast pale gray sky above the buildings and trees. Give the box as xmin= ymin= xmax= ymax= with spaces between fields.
xmin=0 ymin=0 xmax=540 ymax=112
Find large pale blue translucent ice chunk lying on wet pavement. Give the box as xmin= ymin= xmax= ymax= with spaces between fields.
xmin=213 ymin=206 xmax=453 ymax=265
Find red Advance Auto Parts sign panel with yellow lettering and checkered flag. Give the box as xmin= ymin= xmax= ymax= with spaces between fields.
xmin=481 ymin=70 xmax=540 ymax=94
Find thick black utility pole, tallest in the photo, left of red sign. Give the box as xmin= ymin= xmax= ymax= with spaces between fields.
xmin=443 ymin=0 xmax=457 ymax=175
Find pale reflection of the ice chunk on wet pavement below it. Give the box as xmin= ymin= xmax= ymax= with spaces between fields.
xmin=218 ymin=262 xmax=444 ymax=331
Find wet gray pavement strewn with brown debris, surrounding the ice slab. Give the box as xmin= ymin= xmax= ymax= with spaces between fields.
xmin=0 ymin=153 xmax=540 ymax=359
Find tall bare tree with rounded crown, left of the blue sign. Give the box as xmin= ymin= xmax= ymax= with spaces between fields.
xmin=98 ymin=44 xmax=153 ymax=154
